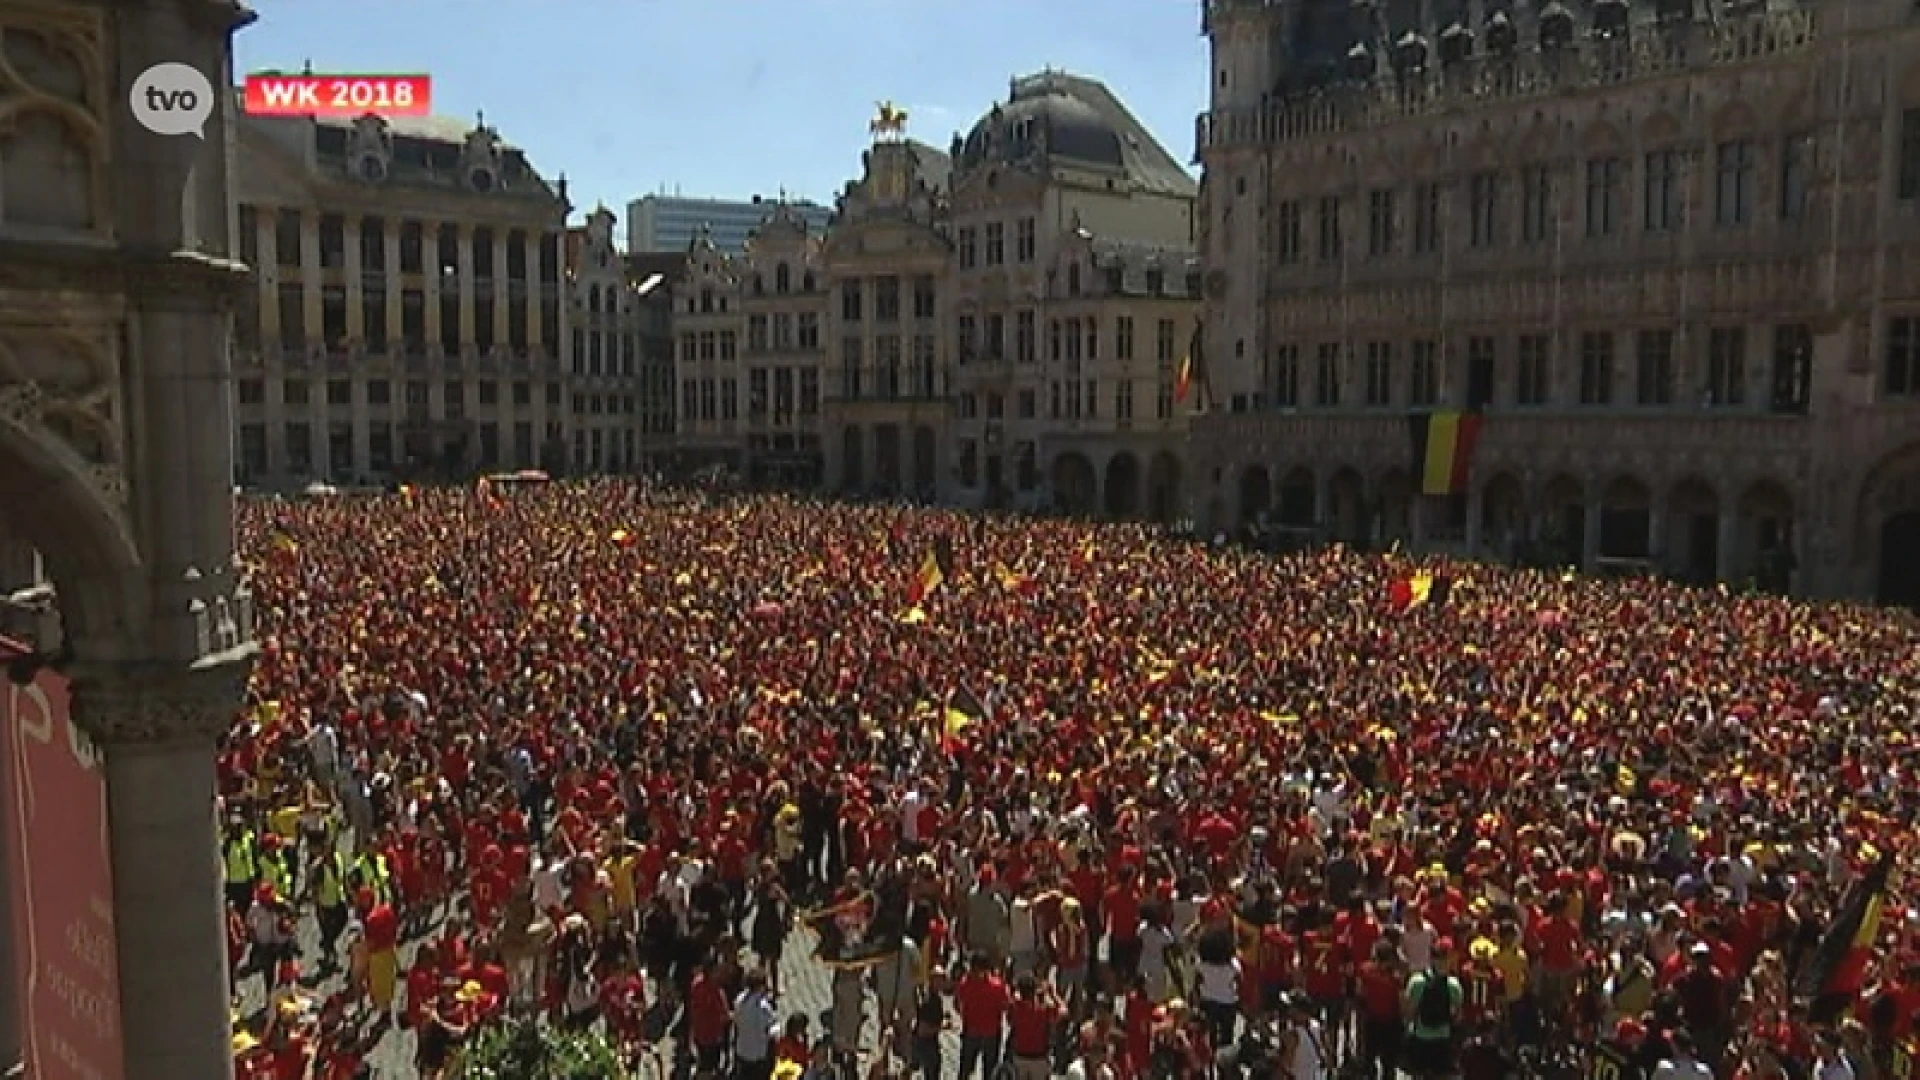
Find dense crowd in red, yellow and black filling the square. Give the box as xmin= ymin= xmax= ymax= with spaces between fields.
xmin=221 ymin=480 xmax=1920 ymax=1080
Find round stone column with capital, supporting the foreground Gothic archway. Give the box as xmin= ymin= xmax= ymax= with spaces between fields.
xmin=73 ymin=661 xmax=246 ymax=1080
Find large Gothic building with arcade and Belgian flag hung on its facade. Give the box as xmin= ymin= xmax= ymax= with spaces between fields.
xmin=1192 ymin=0 xmax=1920 ymax=603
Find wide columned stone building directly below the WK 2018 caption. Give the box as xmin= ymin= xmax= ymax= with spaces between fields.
xmin=234 ymin=115 xmax=572 ymax=488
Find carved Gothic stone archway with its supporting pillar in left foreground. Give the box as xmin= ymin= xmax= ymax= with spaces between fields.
xmin=0 ymin=0 xmax=252 ymax=1080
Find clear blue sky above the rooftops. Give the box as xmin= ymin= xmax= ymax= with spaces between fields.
xmin=234 ymin=0 xmax=1208 ymax=224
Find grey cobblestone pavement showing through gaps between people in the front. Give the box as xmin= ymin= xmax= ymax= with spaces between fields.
xmin=238 ymin=891 xmax=960 ymax=1080
